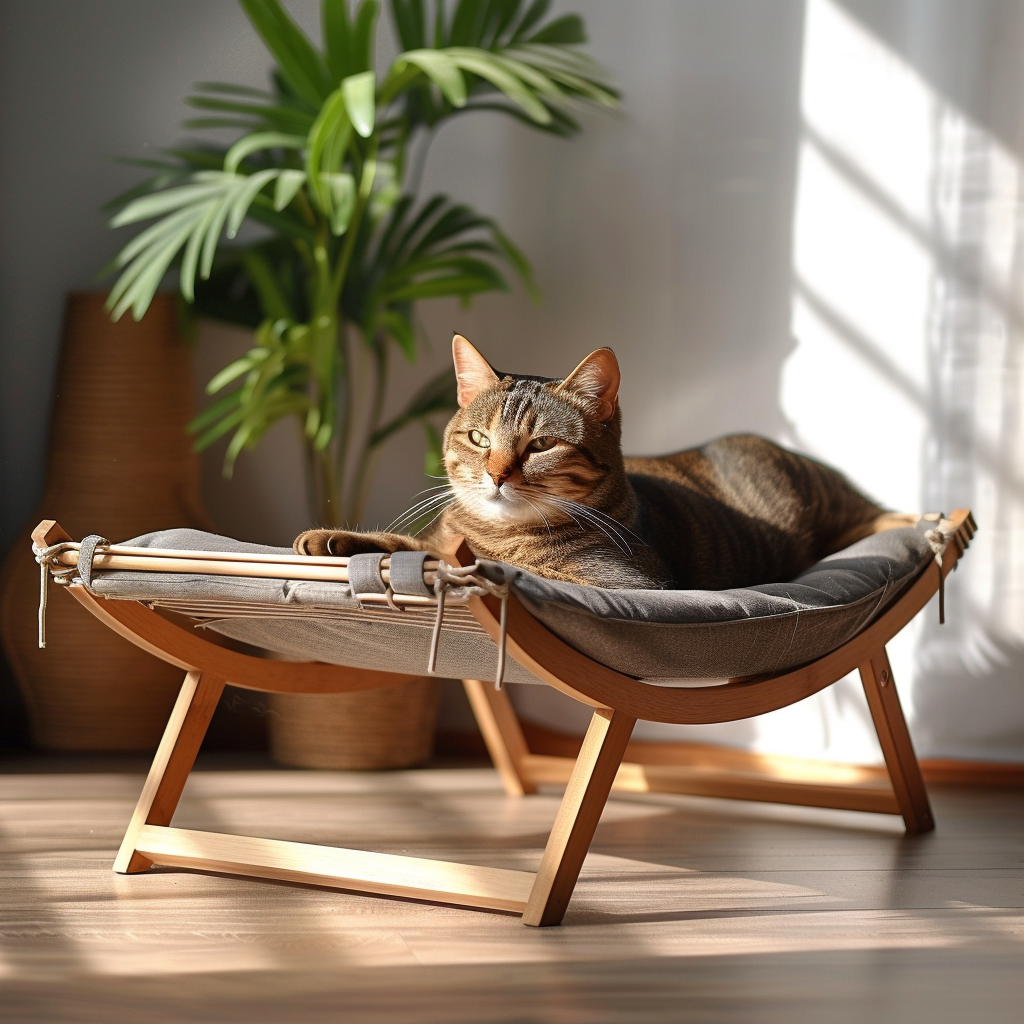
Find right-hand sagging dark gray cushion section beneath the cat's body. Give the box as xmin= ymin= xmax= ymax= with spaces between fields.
xmin=475 ymin=529 xmax=934 ymax=680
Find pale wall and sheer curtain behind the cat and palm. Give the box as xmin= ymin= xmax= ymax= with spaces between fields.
xmin=0 ymin=0 xmax=1024 ymax=759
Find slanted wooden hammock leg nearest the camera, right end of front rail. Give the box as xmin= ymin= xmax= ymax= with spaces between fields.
xmin=522 ymin=708 xmax=636 ymax=926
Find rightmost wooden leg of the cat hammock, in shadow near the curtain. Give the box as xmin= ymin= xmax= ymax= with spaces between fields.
xmin=860 ymin=647 xmax=935 ymax=834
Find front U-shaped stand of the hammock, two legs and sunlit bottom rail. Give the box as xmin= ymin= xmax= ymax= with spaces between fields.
xmin=114 ymin=672 xmax=634 ymax=925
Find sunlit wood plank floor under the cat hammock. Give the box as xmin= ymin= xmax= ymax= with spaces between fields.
xmin=0 ymin=761 xmax=1024 ymax=1024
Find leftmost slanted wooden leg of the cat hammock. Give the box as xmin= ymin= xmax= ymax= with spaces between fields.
xmin=114 ymin=672 xmax=224 ymax=874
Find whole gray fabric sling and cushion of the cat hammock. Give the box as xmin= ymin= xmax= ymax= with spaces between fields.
xmin=93 ymin=529 xmax=933 ymax=683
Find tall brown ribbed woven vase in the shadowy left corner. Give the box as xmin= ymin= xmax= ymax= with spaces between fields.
xmin=0 ymin=293 xmax=207 ymax=751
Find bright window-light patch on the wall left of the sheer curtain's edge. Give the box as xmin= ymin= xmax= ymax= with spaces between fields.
xmin=781 ymin=0 xmax=937 ymax=509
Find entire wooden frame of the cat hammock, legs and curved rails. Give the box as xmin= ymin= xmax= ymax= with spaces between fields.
xmin=33 ymin=510 xmax=975 ymax=926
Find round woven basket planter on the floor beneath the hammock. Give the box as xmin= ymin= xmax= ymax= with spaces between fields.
xmin=269 ymin=679 xmax=440 ymax=770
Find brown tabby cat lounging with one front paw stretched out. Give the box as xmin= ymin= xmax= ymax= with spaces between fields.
xmin=295 ymin=335 xmax=916 ymax=590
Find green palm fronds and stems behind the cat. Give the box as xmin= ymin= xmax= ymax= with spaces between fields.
xmin=109 ymin=0 xmax=617 ymax=770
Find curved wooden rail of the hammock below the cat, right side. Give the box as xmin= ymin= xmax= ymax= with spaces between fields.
xmin=463 ymin=509 xmax=974 ymax=725
